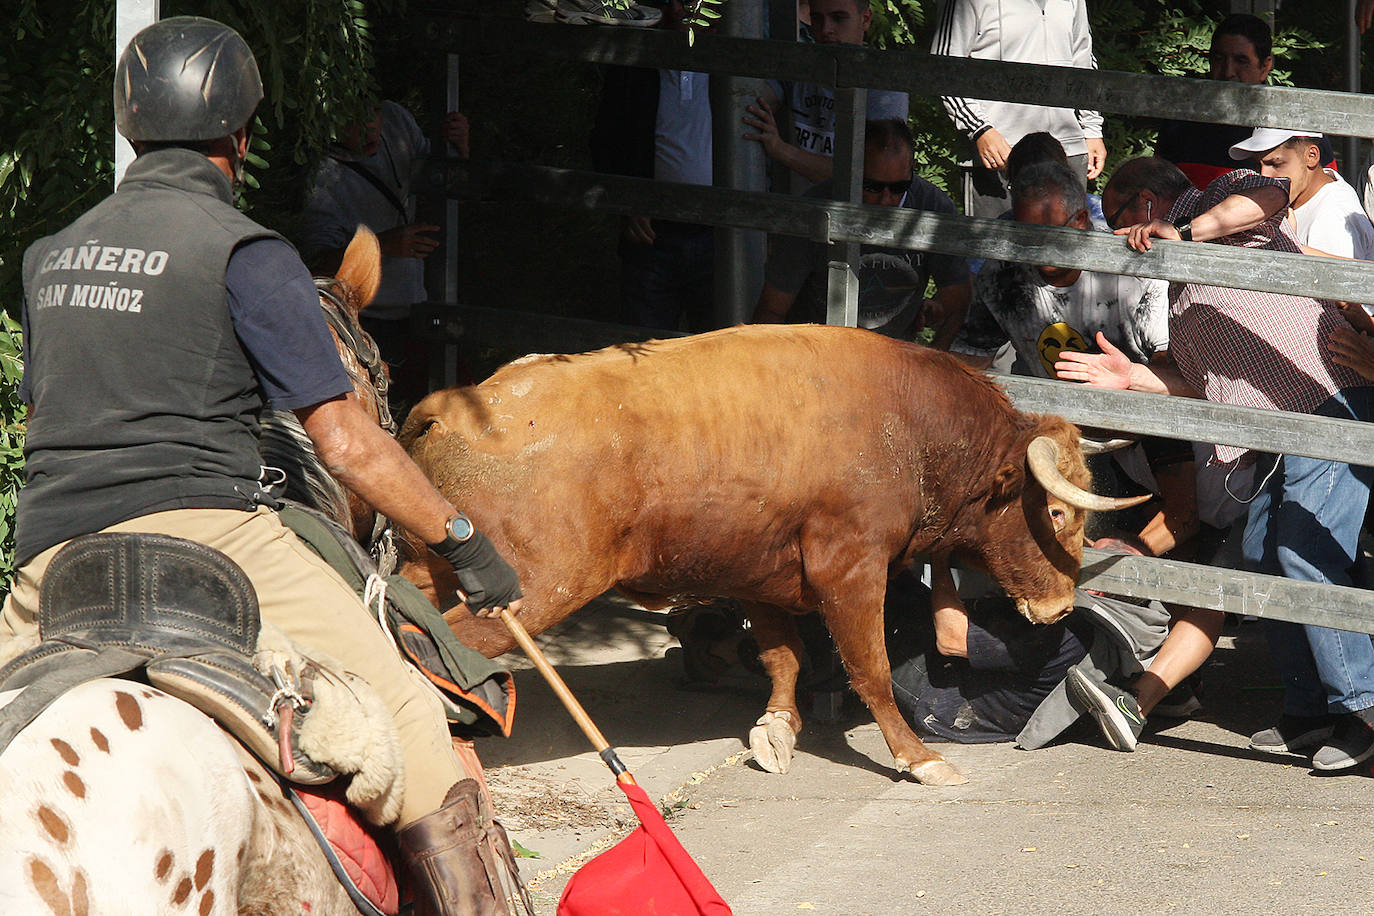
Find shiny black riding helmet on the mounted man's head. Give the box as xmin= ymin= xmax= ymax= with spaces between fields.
xmin=114 ymin=16 xmax=262 ymax=143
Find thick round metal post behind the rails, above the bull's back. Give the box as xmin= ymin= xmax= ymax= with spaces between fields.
xmin=710 ymin=0 xmax=767 ymax=327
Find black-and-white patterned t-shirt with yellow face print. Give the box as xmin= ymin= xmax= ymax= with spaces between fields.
xmin=951 ymin=261 xmax=1169 ymax=379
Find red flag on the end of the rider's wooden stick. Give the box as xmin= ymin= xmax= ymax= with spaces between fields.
xmin=558 ymin=780 xmax=732 ymax=916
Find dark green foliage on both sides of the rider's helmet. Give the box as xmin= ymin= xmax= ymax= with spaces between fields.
xmin=0 ymin=0 xmax=404 ymax=580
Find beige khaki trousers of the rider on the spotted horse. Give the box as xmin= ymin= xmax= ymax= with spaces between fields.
xmin=0 ymin=508 xmax=466 ymax=827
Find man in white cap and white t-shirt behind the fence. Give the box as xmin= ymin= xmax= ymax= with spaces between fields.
xmin=1231 ymin=128 xmax=1374 ymax=261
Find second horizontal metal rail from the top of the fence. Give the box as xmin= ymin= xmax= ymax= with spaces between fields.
xmin=422 ymin=161 xmax=1374 ymax=302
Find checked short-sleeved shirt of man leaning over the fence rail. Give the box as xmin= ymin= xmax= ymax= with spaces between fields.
xmin=1169 ymin=169 xmax=1369 ymax=463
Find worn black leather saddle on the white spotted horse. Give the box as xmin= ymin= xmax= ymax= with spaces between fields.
xmin=0 ymin=533 xmax=337 ymax=784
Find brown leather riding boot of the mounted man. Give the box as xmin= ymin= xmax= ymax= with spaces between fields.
xmin=396 ymin=779 xmax=510 ymax=916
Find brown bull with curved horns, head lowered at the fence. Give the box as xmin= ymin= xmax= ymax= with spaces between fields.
xmin=401 ymin=325 xmax=1137 ymax=784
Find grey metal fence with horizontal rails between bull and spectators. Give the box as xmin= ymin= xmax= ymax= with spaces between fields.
xmin=422 ymin=18 xmax=1374 ymax=633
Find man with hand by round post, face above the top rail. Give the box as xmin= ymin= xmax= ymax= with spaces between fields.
xmin=743 ymin=0 xmax=908 ymax=185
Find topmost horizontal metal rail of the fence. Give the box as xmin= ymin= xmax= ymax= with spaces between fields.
xmin=416 ymin=16 xmax=1374 ymax=137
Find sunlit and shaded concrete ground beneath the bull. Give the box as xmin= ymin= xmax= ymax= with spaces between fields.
xmin=478 ymin=600 xmax=1374 ymax=916
